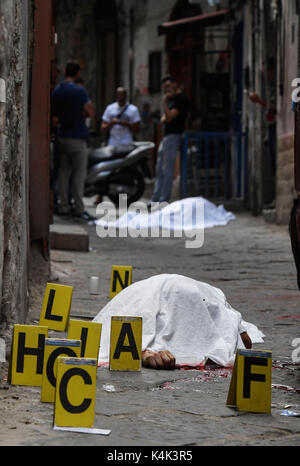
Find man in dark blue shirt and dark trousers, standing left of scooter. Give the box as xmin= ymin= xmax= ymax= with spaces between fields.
xmin=52 ymin=62 xmax=94 ymax=220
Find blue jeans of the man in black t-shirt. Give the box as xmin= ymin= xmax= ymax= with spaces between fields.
xmin=152 ymin=134 xmax=182 ymax=202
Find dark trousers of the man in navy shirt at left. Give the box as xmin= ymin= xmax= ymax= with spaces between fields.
xmin=59 ymin=138 xmax=88 ymax=214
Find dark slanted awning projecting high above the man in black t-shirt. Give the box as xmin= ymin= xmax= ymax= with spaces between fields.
xmin=158 ymin=10 xmax=229 ymax=36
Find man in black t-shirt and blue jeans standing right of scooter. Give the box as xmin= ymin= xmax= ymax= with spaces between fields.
xmin=152 ymin=76 xmax=189 ymax=202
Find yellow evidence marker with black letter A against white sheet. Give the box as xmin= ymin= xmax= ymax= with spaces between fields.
xmin=109 ymin=316 xmax=143 ymax=371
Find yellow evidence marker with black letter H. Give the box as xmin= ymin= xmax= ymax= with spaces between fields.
xmin=9 ymin=324 xmax=48 ymax=387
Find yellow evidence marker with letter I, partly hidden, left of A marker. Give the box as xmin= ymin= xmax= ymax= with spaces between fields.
xmin=68 ymin=319 xmax=102 ymax=359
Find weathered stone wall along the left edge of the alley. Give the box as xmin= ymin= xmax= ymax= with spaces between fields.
xmin=0 ymin=0 xmax=31 ymax=338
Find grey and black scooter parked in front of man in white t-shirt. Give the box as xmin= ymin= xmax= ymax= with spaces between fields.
xmin=84 ymin=141 xmax=155 ymax=206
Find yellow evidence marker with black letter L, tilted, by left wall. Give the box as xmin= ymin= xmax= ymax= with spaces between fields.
xmin=39 ymin=283 xmax=73 ymax=332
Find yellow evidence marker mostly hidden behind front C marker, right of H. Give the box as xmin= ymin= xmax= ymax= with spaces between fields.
xmin=41 ymin=338 xmax=81 ymax=403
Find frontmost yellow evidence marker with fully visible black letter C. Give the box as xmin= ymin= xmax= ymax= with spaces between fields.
xmin=54 ymin=357 xmax=97 ymax=427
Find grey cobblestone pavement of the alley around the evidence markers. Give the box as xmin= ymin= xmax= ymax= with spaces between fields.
xmin=0 ymin=202 xmax=300 ymax=448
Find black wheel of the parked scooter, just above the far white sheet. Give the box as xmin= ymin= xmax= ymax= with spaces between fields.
xmin=108 ymin=170 xmax=145 ymax=207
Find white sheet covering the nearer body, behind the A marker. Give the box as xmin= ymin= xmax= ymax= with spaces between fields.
xmin=94 ymin=274 xmax=264 ymax=366
